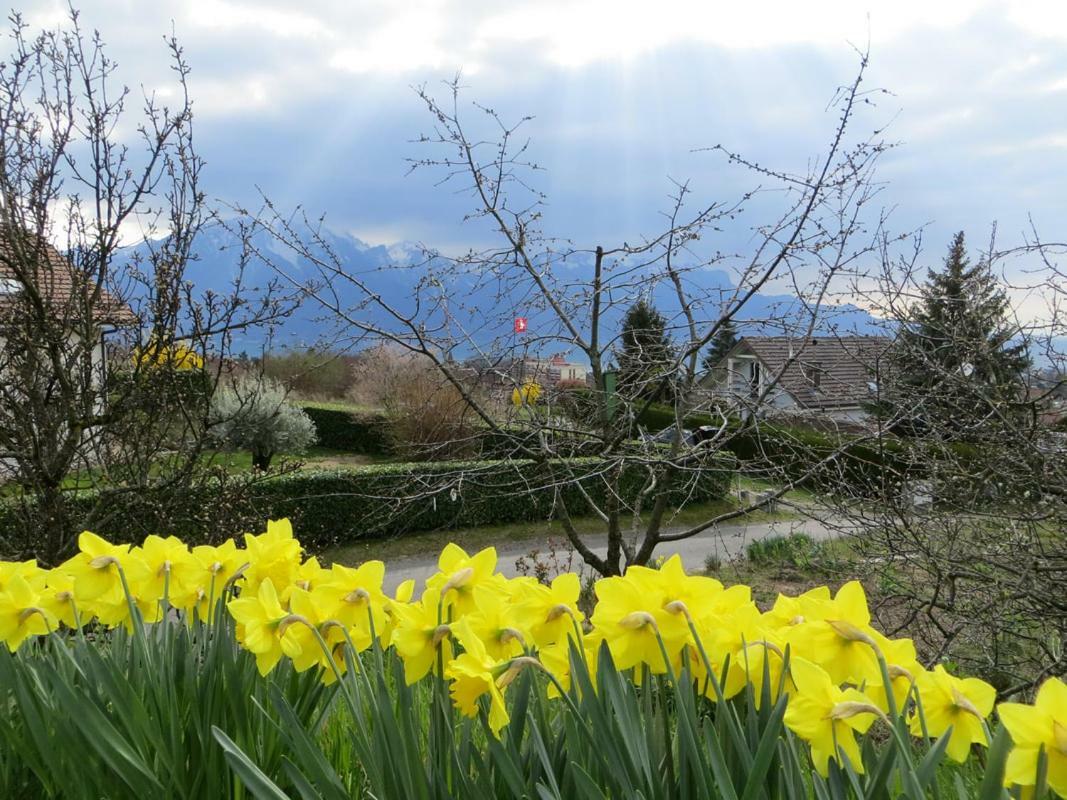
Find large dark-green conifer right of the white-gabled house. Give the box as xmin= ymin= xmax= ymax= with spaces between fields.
xmin=890 ymin=231 xmax=1030 ymax=438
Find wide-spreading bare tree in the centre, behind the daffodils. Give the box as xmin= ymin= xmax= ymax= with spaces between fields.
xmin=235 ymin=54 xmax=889 ymax=575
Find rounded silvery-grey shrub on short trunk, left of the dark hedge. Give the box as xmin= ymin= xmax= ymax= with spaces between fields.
xmin=211 ymin=378 xmax=315 ymax=469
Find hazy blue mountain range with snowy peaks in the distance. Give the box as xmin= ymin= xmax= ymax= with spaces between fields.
xmin=121 ymin=226 xmax=885 ymax=357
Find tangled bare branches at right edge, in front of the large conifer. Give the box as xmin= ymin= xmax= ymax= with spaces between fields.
xmin=806 ymin=228 xmax=1067 ymax=695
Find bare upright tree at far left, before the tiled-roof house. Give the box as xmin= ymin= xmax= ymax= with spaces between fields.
xmin=0 ymin=9 xmax=289 ymax=561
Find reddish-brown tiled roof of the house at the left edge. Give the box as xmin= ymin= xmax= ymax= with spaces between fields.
xmin=0 ymin=229 xmax=136 ymax=325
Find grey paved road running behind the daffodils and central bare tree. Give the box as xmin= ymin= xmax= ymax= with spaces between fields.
xmin=385 ymin=516 xmax=840 ymax=594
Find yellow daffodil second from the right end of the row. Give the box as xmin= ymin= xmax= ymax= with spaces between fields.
xmin=910 ymin=665 xmax=997 ymax=762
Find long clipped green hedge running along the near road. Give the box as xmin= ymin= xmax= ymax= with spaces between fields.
xmin=0 ymin=457 xmax=735 ymax=553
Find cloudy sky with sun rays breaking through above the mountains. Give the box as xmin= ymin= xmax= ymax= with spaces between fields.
xmin=19 ymin=0 xmax=1067 ymax=269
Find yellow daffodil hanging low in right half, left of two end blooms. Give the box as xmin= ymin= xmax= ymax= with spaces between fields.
xmin=785 ymin=658 xmax=881 ymax=778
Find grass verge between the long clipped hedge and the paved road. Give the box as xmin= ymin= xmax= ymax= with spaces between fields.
xmin=322 ymin=478 xmax=810 ymax=564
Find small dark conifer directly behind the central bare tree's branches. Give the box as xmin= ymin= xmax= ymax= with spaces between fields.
xmin=619 ymin=300 xmax=674 ymax=400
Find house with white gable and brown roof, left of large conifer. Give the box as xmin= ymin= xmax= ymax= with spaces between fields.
xmin=700 ymin=336 xmax=890 ymax=425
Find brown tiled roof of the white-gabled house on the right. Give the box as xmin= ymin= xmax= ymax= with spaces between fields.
xmin=728 ymin=336 xmax=890 ymax=409
